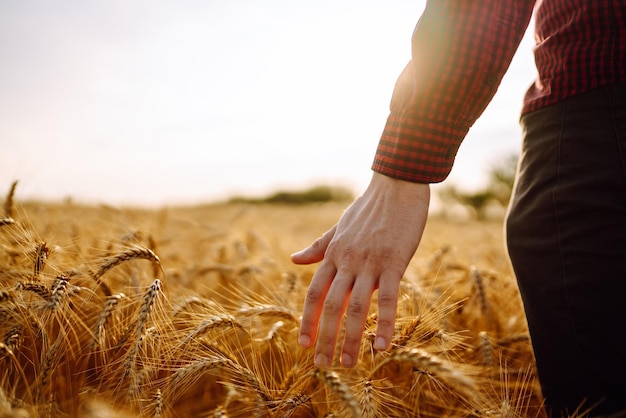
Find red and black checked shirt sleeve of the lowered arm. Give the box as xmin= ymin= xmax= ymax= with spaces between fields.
xmin=372 ymin=0 xmax=535 ymax=183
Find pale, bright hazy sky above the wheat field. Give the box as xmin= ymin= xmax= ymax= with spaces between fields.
xmin=0 ymin=0 xmax=535 ymax=206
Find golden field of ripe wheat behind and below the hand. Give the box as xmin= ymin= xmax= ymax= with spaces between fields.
xmin=0 ymin=187 xmax=544 ymax=418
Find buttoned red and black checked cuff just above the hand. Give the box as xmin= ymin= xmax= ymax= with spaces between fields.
xmin=372 ymin=112 xmax=469 ymax=183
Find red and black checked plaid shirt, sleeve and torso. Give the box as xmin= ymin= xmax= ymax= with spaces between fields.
xmin=372 ymin=0 xmax=626 ymax=183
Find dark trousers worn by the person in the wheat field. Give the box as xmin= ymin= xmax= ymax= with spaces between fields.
xmin=506 ymin=84 xmax=626 ymax=417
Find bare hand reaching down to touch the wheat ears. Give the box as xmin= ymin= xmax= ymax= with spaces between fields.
xmin=291 ymin=173 xmax=430 ymax=367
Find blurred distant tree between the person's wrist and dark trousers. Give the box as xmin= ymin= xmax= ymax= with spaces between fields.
xmin=438 ymin=155 xmax=518 ymax=220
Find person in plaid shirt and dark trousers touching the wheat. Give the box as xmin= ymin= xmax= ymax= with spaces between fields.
xmin=292 ymin=0 xmax=626 ymax=416
